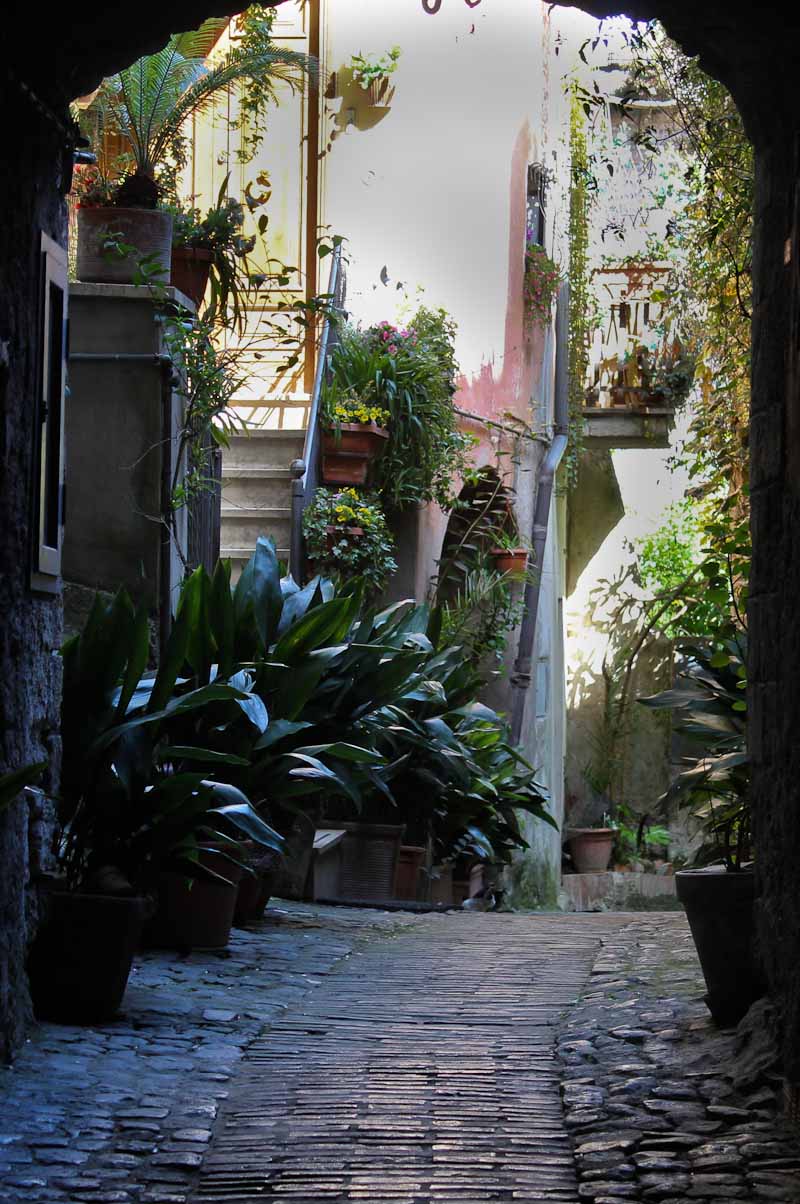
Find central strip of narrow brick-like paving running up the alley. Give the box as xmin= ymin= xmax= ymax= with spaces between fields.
xmin=192 ymin=913 xmax=620 ymax=1204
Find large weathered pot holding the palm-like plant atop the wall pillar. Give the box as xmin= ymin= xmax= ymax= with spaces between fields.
xmin=76 ymin=206 xmax=172 ymax=284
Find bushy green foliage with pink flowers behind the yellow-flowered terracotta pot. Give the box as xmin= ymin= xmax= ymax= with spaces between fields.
xmin=329 ymin=307 xmax=473 ymax=509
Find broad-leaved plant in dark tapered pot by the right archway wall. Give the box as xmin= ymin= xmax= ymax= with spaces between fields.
xmin=639 ymin=635 xmax=765 ymax=1025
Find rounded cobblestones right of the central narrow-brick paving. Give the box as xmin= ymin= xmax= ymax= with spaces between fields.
xmin=559 ymin=914 xmax=800 ymax=1204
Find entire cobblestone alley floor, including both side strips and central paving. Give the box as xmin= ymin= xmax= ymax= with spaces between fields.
xmin=0 ymin=904 xmax=800 ymax=1204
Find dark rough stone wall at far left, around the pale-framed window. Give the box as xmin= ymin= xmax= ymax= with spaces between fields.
xmin=0 ymin=75 xmax=69 ymax=1057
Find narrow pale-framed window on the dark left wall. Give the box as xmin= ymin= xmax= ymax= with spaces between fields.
xmin=31 ymin=234 xmax=67 ymax=592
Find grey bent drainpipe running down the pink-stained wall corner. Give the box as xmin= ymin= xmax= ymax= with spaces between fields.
xmin=511 ymin=282 xmax=570 ymax=744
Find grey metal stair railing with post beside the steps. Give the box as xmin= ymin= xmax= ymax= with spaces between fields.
xmin=289 ymin=246 xmax=345 ymax=585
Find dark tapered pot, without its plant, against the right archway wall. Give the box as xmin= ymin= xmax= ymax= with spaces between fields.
xmin=675 ymin=867 xmax=766 ymax=1025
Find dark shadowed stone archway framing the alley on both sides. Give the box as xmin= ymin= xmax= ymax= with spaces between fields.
xmin=0 ymin=0 xmax=800 ymax=1084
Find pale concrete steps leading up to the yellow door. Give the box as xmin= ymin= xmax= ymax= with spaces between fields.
xmin=219 ymin=430 xmax=305 ymax=582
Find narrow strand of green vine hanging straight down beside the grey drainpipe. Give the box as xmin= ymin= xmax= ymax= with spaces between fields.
xmin=564 ymin=92 xmax=594 ymax=486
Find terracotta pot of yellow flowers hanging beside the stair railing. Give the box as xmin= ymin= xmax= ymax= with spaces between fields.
xmin=322 ymin=385 xmax=389 ymax=485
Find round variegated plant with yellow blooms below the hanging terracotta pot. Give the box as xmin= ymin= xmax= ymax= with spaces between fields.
xmin=302 ymin=489 xmax=398 ymax=594
